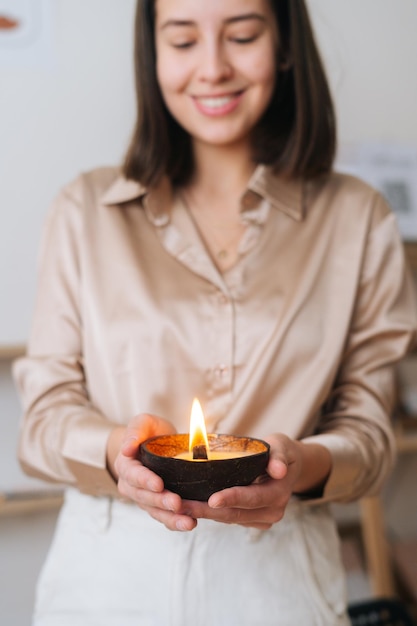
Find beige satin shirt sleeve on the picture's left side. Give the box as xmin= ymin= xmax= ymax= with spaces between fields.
xmin=13 ymin=180 xmax=118 ymax=496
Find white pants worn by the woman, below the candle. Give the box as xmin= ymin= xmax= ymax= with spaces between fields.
xmin=33 ymin=490 xmax=350 ymax=626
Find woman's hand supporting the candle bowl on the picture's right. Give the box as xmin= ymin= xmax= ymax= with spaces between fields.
xmin=182 ymin=434 xmax=331 ymax=530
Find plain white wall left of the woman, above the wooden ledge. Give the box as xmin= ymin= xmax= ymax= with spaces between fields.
xmin=0 ymin=0 xmax=134 ymax=345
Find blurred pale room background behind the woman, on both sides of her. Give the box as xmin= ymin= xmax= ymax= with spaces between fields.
xmin=0 ymin=0 xmax=417 ymax=626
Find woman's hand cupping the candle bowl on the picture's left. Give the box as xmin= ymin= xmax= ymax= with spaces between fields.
xmin=108 ymin=413 xmax=197 ymax=530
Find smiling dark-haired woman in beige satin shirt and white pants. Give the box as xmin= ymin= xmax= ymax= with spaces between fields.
xmin=15 ymin=0 xmax=416 ymax=626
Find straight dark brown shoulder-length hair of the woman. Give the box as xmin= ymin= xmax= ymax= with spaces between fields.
xmin=123 ymin=0 xmax=336 ymax=185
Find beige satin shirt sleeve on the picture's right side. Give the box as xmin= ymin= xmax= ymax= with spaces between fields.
xmin=303 ymin=194 xmax=417 ymax=502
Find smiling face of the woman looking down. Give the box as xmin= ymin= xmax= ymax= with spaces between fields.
xmin=155 ymin=0 xmax=278 ymax=152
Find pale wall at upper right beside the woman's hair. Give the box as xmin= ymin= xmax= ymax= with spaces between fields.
xmin=307 ymin=0 xmax=417 ymax=145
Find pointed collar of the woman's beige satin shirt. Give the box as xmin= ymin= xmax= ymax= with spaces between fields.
xmin=101 ymin=165 xmax=305 ymax=226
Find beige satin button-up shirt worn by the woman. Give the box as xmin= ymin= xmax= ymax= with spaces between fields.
xmin=14 ymin=166 xmax=417 ymax=501
